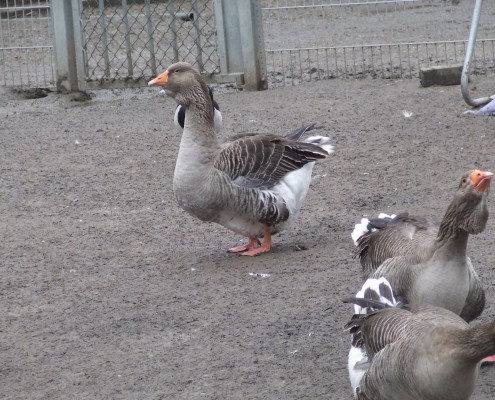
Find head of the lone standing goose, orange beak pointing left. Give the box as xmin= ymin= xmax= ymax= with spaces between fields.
xmin=148 ymin=62 xmax=213 ymax=108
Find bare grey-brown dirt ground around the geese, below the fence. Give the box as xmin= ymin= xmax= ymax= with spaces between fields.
xmin=0 ymin=78 xmax=495 ymax=400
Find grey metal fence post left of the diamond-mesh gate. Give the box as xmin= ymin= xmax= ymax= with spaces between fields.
xmin=51 ymin=0 xmax=84 ymax=92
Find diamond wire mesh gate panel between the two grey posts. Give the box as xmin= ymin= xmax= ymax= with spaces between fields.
xmin=82 ymin=0 xmax=220 ymax=81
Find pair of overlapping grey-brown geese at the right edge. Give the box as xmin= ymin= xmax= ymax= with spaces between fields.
xmin=347 ymin=170 xmax=495 ymax=400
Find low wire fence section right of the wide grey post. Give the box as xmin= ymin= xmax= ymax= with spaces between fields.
xmin=261 ymin=0 xmax=495 ymax=87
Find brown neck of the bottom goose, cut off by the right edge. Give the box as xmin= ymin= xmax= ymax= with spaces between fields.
xmin=455 ymin=321 xmax=495 ymax=363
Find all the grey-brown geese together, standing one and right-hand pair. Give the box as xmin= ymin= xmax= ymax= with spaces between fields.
xmin=148 ymin=62 xmax=495 ymax=400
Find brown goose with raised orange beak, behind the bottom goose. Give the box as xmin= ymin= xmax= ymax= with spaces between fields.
xmin=356 ymin=170 xmax=493 ymax=322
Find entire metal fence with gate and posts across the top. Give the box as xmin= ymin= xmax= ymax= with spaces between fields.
xmin=0 ymin=0 xmax=495 ymax=89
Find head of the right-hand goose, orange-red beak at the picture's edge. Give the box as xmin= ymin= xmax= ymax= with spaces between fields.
xmin=447 ymin=169 xmax=493 ymax=234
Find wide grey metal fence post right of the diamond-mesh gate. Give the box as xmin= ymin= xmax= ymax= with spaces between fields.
xmin=215 ymin=0 xmax=268 ymax=90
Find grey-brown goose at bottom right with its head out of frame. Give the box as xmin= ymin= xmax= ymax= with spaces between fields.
xmin=346 ymin=278 xmax=495 ymax=400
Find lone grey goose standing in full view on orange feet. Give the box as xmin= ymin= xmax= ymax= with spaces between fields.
xmin=148 ymin=62 xmax=333 ymax=256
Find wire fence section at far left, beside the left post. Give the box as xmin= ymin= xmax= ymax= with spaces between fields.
xmin=0 ymin=0 xmax=55 ymax=87
